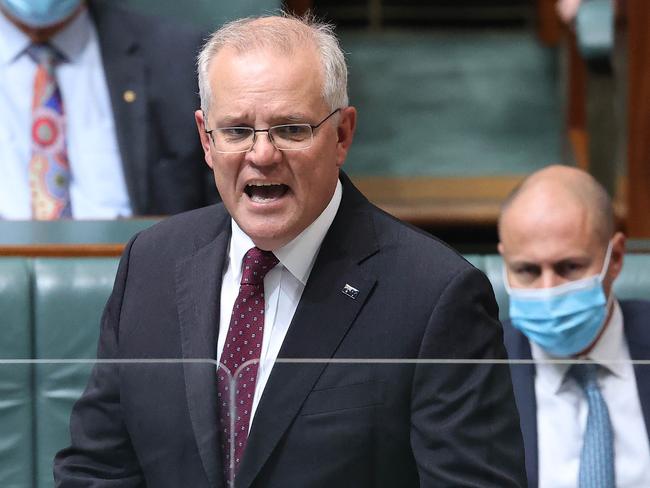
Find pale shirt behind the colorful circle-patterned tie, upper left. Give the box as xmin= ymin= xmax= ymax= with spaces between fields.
xmin=0 ymin=10 xmax=131 ymax=219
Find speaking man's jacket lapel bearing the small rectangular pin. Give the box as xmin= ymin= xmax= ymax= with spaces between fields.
xmin=237 ymin=178 xmax=378 ymax=488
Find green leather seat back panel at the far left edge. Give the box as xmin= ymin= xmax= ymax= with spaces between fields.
xmin=0 ymin=258 xmax=34 ymax=488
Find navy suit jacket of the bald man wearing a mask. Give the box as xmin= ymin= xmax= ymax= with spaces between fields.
xmin=503 ymin=300 xmax=650 ymax=488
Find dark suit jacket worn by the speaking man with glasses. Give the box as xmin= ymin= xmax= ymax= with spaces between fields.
xmin=55 ymin=175 xmax=526 ymax=488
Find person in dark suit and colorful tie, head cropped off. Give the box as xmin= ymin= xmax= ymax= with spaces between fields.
xmin=0 ymin=0 xmax=218 ymax=218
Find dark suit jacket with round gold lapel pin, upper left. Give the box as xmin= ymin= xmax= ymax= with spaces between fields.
xmin=89 ymin=0 xmax=218 ymax=215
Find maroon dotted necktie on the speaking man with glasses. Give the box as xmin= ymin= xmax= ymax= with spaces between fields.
xmin=217 ymin=247 xmax=278 ymax=486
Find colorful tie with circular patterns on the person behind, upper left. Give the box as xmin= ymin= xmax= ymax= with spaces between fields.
xmin=27 ymin=44 xmax=72 ymax=220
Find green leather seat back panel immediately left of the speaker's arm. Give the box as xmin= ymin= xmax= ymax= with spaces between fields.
xmin=33 ymin=258 xmax=118 ymax=488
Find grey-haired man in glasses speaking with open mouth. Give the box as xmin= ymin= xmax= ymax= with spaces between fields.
xmin=55 ymin=13 xmax=526 ymax=488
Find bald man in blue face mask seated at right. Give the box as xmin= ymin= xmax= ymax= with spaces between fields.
xmin=499 ymin=166 xmax=650 ymax=488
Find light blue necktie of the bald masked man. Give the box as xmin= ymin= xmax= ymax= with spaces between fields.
xmin=569 ymin=364 xmax=616 ymax=488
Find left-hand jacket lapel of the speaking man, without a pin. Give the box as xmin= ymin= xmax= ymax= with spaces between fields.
xmin=176 ymin=214 xmax=230 ymax=486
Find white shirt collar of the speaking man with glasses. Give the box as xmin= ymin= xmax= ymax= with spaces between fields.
xmin=229 ymin=181 xmax=343 ymax=286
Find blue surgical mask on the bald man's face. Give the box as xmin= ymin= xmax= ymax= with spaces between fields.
xmin=504 ymin=242 xmax=612 ymax=357
